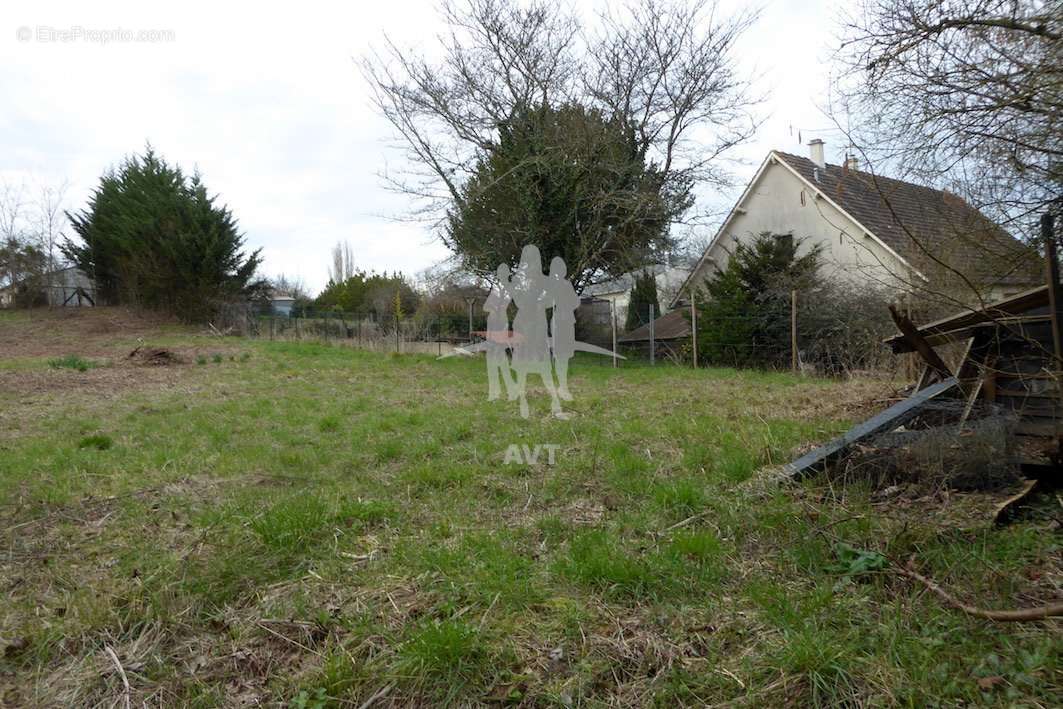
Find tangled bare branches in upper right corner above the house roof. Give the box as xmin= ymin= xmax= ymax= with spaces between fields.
xmin=839 ymin=0 xmax=1063 ymax=225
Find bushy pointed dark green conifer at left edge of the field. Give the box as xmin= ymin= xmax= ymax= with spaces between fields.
xmin=63 ymin=146 xmax=265 ymax=320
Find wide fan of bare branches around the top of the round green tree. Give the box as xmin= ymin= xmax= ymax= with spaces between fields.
xmin=362 ymin=0 xmax=755 ymax=230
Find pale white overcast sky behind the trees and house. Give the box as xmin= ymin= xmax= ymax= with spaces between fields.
xmin=0 ymin=0 xmax=844 ymax=290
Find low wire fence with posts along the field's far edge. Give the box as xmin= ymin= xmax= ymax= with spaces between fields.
xmin=226 ymin=297 xmax=907 ymax=375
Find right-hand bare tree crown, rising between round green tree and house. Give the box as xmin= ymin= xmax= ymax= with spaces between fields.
xmin=584 ymin=0 xmax=758 ymax=200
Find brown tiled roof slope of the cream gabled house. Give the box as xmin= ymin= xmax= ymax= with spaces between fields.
xmin=775 ymin=151 xmax=1041 ymax=285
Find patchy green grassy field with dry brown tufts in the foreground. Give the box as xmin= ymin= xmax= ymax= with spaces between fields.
xmin=0 ymin=310 xmax=1063 ymax=707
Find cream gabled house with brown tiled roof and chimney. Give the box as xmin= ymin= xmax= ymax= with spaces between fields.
xmin=672 ymin=139 xmax=1042 ymax=306
